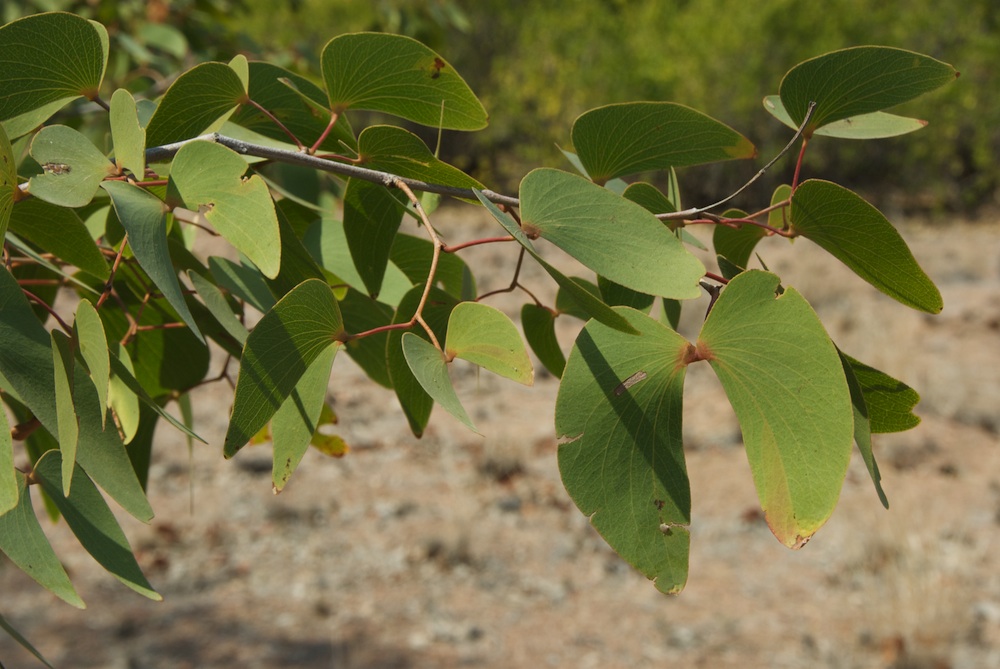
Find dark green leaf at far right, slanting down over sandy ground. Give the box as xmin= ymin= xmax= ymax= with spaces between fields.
xmin=791 ymin=179 xmax=944 ymax=314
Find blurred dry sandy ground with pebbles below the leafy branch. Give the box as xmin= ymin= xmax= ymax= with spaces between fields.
xmin=0 ymin=212 xmax=1000 ymax=669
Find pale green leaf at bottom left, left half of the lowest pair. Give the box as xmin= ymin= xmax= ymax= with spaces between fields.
xmin=0 ymin=475 xmax=85 ymax=609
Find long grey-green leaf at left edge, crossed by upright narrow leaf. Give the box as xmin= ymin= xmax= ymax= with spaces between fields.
xmin=0 ymin=272 xmax=153 ymax=522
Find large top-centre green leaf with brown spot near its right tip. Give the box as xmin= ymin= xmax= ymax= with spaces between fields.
xmin=321 ymin=33 xmax=488 ymax=130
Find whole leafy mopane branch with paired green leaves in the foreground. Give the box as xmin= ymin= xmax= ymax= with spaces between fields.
xmin=0 ymin=13 xmax=957 ymax=664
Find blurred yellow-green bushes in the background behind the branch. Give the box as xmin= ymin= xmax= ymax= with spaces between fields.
xmin=3 ymin=0 xmax=1000 ymax=210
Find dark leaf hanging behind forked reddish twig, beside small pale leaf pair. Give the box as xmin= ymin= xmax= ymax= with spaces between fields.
xmin=385 ymin=286 xmax=458 ymax=437
